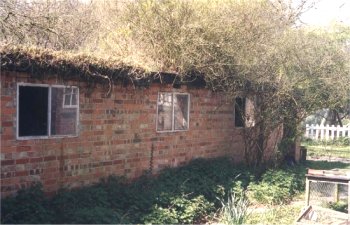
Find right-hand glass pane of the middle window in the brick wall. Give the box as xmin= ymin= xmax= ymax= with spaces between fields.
xmin=174 ymin=94 xmax=189 ymax=130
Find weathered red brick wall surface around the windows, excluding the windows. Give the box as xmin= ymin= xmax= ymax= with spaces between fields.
xmin=0 ymin=71 xmax=243 ymax=196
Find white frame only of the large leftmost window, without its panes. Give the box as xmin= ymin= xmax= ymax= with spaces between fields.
xmin=16 ymin=83 xmax=80 ymax=140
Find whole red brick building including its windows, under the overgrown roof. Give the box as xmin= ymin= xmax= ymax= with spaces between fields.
xmin=1 ymin=47 xmax=284 ymax=196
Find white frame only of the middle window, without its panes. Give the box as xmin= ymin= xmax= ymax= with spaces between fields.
xmin=156 ymin=92 xmax=191 ymax=133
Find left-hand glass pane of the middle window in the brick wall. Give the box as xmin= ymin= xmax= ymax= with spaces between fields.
xmin=157 ymin=93 xmax=173 ymax=131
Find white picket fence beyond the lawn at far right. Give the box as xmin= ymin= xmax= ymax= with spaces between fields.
xmin=305 ymin=124 xmax=350 ymax=140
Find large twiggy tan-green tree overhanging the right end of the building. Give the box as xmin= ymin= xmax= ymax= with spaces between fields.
xmin=97 ymin=0 xmax=349 ymax=166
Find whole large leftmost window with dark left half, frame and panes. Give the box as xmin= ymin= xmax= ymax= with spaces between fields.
xmin=17 ymin=83 xmax=79 ymax=139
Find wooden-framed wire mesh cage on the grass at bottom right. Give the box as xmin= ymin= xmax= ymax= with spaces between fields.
xmin=297 ymin=169 xmax=350 ymax=224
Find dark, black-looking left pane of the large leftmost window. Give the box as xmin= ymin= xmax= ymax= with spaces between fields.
xmin=18 ymin=86 xmax=49 ymax=137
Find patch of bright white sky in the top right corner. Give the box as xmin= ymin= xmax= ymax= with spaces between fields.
xmin=295 ymin=0 xmax=350 ymax=26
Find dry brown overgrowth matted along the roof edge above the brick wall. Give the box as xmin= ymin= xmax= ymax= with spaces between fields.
xmin=0 ymin=45 xmax=205 ymax=90
